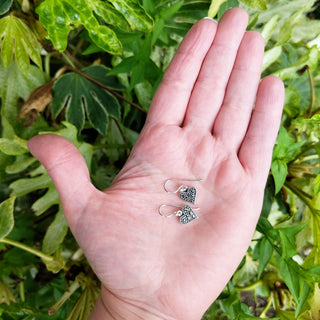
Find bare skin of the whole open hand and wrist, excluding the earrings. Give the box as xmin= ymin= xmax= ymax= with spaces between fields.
xmin=28 ymin=8 xmax=284 ymax=320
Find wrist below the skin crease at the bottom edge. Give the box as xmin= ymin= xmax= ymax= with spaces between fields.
xmin=89 ymin=288 xmax=175 ymax=320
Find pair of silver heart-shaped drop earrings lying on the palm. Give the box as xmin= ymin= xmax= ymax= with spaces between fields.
xmin=158 ymin=179 xmax=202 ymax=224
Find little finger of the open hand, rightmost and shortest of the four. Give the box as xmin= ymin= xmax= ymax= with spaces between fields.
xmin=239 ymin=76 xmax=284 ymax=182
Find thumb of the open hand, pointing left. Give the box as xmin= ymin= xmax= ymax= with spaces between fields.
xmin=28 ymin=134 xmax=94 ymax=229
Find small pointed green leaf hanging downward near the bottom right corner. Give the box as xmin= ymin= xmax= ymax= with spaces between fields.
xmin=279 ymin=259 xmax=300 ymax=302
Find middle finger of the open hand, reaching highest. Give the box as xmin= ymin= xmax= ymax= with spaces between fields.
xmin=183 ymin=8 xmax=248 ymax=132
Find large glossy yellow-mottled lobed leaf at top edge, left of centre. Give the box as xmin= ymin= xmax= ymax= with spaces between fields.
xmin=36 ymin=0 xmax=122 ymax=54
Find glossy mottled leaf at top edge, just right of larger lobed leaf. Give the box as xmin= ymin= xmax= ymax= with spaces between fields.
xmin=109 ymin=0 xmax=153 ymax=32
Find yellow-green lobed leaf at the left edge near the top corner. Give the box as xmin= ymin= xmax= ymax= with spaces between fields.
xmin=0 ymin=14 xmax=42 ymax=75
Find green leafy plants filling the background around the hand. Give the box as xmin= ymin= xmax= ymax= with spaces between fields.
xmin=0 ymin=0 xmax=320 ymax=320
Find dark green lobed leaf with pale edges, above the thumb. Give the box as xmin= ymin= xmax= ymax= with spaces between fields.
xmin=51 ymin=66 xmax=120 ymax=135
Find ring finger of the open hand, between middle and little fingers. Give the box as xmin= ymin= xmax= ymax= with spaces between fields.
xmin=213 ymin=31 xmax=264 ymax=153
